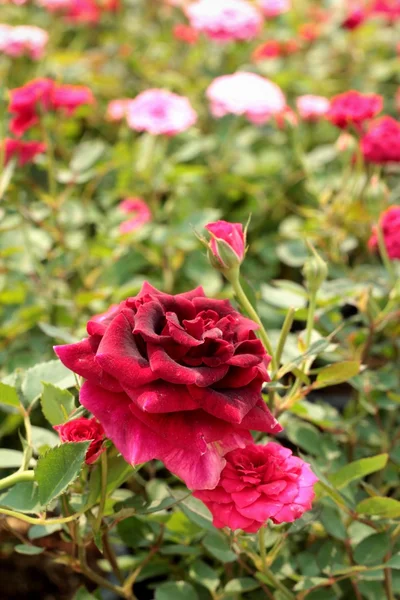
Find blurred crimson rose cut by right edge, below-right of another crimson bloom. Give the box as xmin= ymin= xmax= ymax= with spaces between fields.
xmin=361 ymin=117 xmax=400 ymax=165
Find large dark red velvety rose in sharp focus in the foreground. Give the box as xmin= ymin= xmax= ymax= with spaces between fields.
xmin=55 ymin=283 xmax=281 ymax=489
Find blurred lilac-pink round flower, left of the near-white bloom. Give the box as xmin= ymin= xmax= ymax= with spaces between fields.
xmin=127 ymin=89 xmax=197 ymax=136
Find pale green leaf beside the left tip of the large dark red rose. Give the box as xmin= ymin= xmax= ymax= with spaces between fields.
xmin=21 ymin=360 xmax=76 ymax=403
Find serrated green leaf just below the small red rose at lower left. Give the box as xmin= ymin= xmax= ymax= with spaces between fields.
xmin=35 ymin=442 xmax=90 ymax=506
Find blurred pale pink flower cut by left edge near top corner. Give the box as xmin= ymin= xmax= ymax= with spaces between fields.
xmin=0 ymin=24 xmax=49 ymax=60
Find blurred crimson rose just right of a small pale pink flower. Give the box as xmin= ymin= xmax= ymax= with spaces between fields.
xmin=327 ymin=90 xmax=383 ymax=129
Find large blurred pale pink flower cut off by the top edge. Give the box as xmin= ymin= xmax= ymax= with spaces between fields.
xmin=186 ymin=0 xmax=262 ymax=42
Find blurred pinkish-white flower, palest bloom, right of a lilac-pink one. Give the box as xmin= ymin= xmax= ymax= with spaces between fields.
xmin=206 ymin=71 xmax=286 ymax=125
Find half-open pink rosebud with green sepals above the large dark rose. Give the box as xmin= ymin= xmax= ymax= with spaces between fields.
xmin=205 ymin=221 xmax=246 ymax=268
